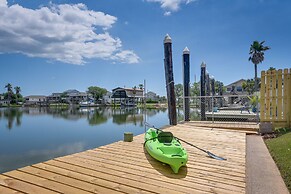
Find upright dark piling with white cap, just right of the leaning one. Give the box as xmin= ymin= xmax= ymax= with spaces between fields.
xmin=183 ymin=47 xmax=190 ymax=121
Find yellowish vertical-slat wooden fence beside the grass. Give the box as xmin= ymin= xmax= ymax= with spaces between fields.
xmin=260 ymin=69 xmax=291 ymax=127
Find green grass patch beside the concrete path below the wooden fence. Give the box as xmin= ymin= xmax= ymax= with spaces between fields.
xmin=265 ymin=128 xmax=291 ymax=193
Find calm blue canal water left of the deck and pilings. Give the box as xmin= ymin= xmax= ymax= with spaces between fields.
xmin=0 ymin=107 xmax=176 ymax=173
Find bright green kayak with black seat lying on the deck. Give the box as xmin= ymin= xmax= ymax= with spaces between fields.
xmin=144 ymin=128 xmax=188 ymax=173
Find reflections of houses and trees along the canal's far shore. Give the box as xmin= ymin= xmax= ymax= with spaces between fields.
xmin=0 ymin=107 xmax=168 ymax=130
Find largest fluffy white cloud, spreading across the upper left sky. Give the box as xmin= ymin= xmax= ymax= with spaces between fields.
xmin=0 ymin=0 xmax=140 ymax=64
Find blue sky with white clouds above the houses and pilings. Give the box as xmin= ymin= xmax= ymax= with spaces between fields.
xmin=0 ymin=0 xmax=291 ymax=95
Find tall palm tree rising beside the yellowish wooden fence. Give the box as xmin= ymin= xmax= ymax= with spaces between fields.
xmin=249 ymin=41 xmax=270 ymax=91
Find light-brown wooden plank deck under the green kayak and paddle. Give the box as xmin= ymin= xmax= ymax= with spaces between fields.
xmin=0 ymin=122 xmax=246 ymax=194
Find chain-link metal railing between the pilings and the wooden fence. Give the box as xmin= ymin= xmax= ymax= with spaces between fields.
xmin=177 ymin=95 xmax=260 ymax=123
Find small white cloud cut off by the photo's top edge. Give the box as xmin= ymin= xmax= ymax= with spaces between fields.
xmin=147 ymin=0 xmax=196 ymax=16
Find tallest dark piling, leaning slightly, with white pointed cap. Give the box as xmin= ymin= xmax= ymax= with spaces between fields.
xmin=164 ymin=34 xmax=177 ymax=125
